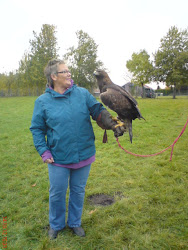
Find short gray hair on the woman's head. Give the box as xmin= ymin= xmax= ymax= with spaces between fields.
xmin=44 ymin=59 xmax=65 ymax=88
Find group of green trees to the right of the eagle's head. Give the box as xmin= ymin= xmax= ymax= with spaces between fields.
xmin=126 ymin=26 xmax=188 ymax=98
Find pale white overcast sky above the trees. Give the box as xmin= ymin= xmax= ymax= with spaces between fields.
xmin=0 ymin=0 xmax=188 ymax=87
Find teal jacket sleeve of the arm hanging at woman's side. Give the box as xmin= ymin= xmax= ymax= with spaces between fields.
xmin=30 ymin=99 xmax=49 ymax=155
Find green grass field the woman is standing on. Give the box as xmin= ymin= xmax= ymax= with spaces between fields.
xmin=0 ymin=97 xmax=188 ymax=250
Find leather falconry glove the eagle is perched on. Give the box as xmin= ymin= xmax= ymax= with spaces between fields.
xmin=97 ymin=109 xmax=125 ymax=137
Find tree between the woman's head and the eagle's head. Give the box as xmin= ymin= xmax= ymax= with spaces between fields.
xmin=64 ymin=30 xmax=103 ymax=91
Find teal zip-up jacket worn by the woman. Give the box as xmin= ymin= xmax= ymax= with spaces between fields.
xmin=30 ymin=85 xmax=104 ymax=164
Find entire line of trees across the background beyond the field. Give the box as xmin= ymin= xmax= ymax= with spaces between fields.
xmin=0 ymin=24 xmax=188 ymax=98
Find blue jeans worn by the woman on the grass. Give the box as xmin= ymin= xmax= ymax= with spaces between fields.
xmin=48 ymin=164 xmax=91 ymax=230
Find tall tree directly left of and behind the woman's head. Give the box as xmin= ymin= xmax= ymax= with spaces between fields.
xmin=18 ymin=24 xmax=58 ymax=95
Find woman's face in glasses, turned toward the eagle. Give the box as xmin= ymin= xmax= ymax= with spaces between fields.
xmin=54 ymin=64 xmax=71 ymax=89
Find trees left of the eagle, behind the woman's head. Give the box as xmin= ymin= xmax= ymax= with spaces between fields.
xmin=0 ymin=24 xmax=103 ymax=96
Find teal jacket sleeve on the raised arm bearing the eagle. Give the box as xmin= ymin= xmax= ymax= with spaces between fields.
xmin=87 ymin=91 xmax=105 ymax=121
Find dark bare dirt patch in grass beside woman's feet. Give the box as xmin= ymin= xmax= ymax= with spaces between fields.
xmin=88 ymin=194 xmax=115 ymax=206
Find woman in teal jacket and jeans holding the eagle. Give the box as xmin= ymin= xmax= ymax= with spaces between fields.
xmin=30 ymin=59 xmax=124 ymax=239
